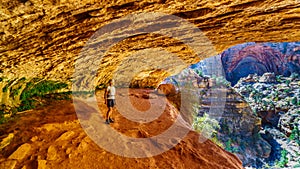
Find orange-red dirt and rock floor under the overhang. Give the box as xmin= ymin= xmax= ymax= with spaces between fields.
xmin=0 ymin=89 xmax=243 ymax=169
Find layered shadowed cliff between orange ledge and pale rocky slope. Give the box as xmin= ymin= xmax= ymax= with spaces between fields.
xmin=166 ymin=67 xmax=272 ymax=168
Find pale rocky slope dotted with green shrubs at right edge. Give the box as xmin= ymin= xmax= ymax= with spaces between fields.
xmin=234 ymin=73 xmax=300 ymax=168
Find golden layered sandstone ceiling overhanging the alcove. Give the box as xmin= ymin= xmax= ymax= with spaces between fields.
xmin=0 ymin=0 xmax=300 ymax=86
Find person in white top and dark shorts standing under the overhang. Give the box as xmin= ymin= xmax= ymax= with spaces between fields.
xmin=104 ymin=80 xmax=116 ymax=124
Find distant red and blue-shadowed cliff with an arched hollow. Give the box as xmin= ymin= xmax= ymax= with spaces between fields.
xmin=221 ymin=42 xmax=300 ymax=85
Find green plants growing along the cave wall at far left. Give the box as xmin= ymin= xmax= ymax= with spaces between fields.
xmin=0 ymin=77 xmax=70 ymax=118
